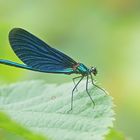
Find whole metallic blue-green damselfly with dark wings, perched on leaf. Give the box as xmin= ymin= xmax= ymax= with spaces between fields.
xmin=0 ymin=28 xmax=105 ymax=110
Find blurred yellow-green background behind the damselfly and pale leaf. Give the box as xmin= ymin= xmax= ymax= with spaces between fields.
xmin=0 ymin=0 xmax=140 ymax=140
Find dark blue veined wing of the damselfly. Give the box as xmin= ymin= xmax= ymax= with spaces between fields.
xmin=9 ymin=28 xmax=77 ymax=73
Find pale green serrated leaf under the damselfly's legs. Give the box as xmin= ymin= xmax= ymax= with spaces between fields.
xmin=0 ymin=81 xmax=114 ymax=140
